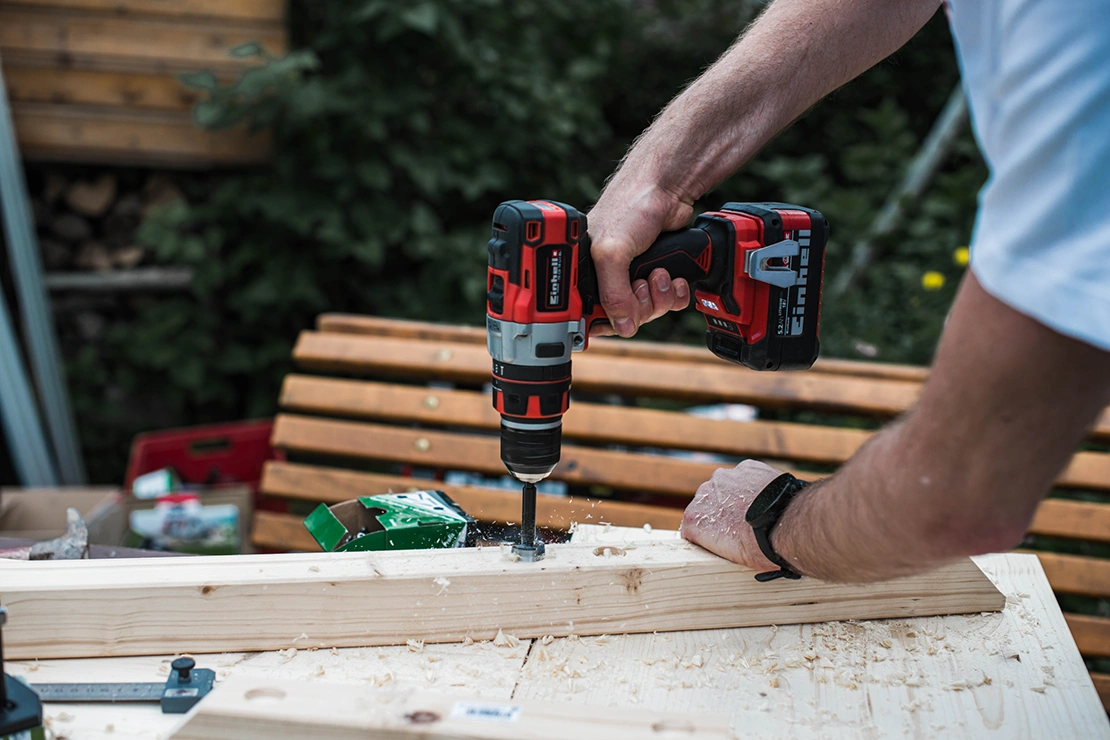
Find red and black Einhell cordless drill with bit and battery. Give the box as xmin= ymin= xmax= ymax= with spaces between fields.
xmin=486 ymin=201 xmax=828 ymax=560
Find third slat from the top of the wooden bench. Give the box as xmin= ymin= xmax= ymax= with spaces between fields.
xmin=279 ymin=375 xmax=870 ymax=465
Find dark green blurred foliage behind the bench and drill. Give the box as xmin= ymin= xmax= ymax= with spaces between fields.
xmin=70 ymin=0 xmax=981 ymax=479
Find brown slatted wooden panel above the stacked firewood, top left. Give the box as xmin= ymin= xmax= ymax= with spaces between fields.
xmin=0 ymin=0 xmax=286 ymax=166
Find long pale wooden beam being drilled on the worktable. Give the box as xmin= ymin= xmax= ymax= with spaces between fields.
xmin=0 ymin=543 xmax=1005 ymax=660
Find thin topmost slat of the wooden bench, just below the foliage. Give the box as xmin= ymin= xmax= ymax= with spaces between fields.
xmin=316 ymin=314 xmax=929 ymax=382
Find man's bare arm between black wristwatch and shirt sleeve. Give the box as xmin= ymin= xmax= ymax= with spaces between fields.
xmin=771 ymin=274 xmax=1110 ymax=581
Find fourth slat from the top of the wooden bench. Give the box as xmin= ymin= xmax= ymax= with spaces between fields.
xmin=271 ymin=414 xmax=737 ymax=497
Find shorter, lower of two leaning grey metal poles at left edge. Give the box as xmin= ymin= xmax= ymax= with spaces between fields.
xmin=0 ymin=277 xmax=58 ymax=487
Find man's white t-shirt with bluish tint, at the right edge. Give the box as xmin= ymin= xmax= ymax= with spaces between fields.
xmin=949 ymin=0 xmax=1110 ymax=349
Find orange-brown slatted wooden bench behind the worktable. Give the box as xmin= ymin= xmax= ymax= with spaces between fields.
xmin=253 ymin=315 xmax=1110 ymax=707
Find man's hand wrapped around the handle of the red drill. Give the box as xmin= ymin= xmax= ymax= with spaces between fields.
xmin=589 ymin=184 xmax=694 ymax=336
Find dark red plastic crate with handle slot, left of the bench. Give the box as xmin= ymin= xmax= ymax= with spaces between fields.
xmin=123 ymin=419 xmax=280 ymax=490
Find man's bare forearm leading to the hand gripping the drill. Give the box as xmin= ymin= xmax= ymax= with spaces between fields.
xmin=616 ymin=0 xmax=940 ymax=203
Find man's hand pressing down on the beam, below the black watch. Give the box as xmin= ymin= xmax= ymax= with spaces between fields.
xmin=682 ymin=460 xmax=781 ymax=571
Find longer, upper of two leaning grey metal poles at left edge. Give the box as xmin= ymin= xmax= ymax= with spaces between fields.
xmin=0 ymin=49 xmax=85 ymax=486
